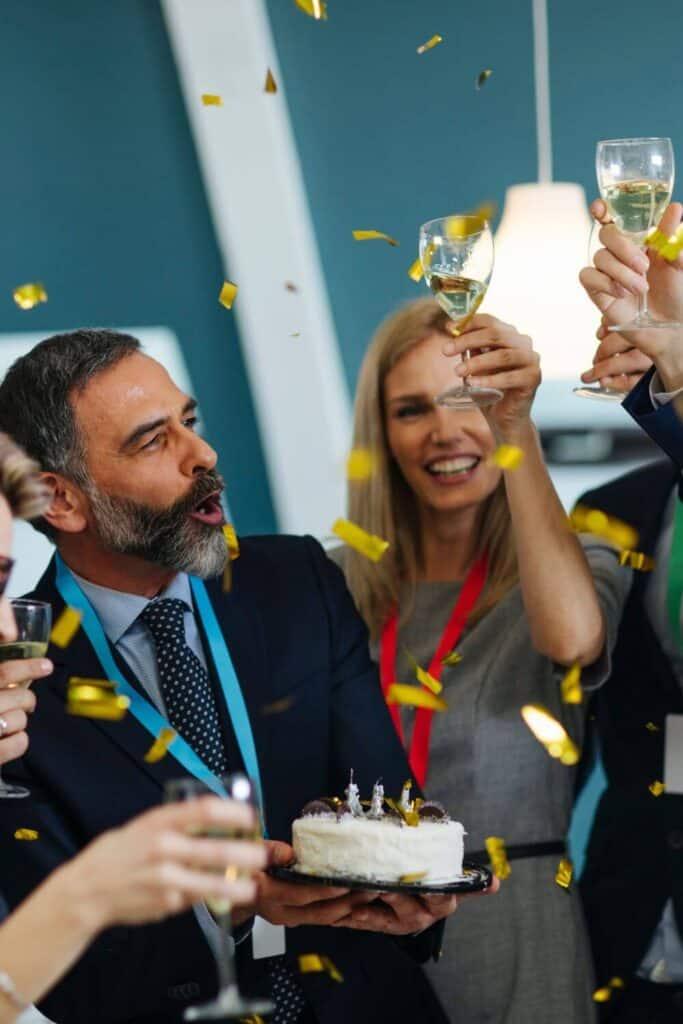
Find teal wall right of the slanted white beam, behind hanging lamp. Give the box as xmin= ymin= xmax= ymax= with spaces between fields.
xmin=267 ymin=0 xmax=683 ymax=385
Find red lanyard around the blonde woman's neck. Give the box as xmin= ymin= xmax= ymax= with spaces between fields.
xmin=380 ymin=555 xmax=487 ymax=788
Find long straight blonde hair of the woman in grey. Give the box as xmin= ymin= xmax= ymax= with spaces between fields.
xmin=346 ymin=298 xmax=518 ymax=638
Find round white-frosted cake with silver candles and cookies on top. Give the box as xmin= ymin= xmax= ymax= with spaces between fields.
xmin=292 ymin=773 xmax=465 ymax=885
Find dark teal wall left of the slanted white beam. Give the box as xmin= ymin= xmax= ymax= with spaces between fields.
xmin=0 ymin=0 xmax=274 ymax=531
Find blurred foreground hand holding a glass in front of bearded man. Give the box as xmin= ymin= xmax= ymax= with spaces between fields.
xmin=55 ymin=796 xmax=267 ymax=934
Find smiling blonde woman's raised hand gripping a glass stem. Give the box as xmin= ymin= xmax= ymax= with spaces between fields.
xmin=443 ymin=313 xmax=541 ymax=442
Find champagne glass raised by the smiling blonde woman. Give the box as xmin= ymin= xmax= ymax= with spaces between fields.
xmin=420 ymin=214 xmax=503 ymax=409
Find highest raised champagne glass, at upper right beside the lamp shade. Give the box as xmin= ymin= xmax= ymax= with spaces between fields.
xmin=595 ymin=138 xmax=681 ymax=333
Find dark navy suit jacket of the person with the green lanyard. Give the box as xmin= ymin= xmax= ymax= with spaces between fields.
xmin=580 ymin=371 xmax=683 ymax=998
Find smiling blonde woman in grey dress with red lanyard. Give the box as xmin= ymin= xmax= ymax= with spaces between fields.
xmin=334 ymin=299 xmax=630 ymax=1024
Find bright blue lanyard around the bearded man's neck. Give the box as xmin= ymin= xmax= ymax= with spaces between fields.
xmin=55 ymin=555 xmax=263 ymax=803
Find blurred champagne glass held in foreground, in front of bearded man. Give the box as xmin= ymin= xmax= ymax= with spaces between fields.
xmin=165 ymin=772 xmax=273 ymax=1021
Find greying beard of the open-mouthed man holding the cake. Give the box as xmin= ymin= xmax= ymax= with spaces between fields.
xmin=87 ymin=484 xmax=228 ymax=580
